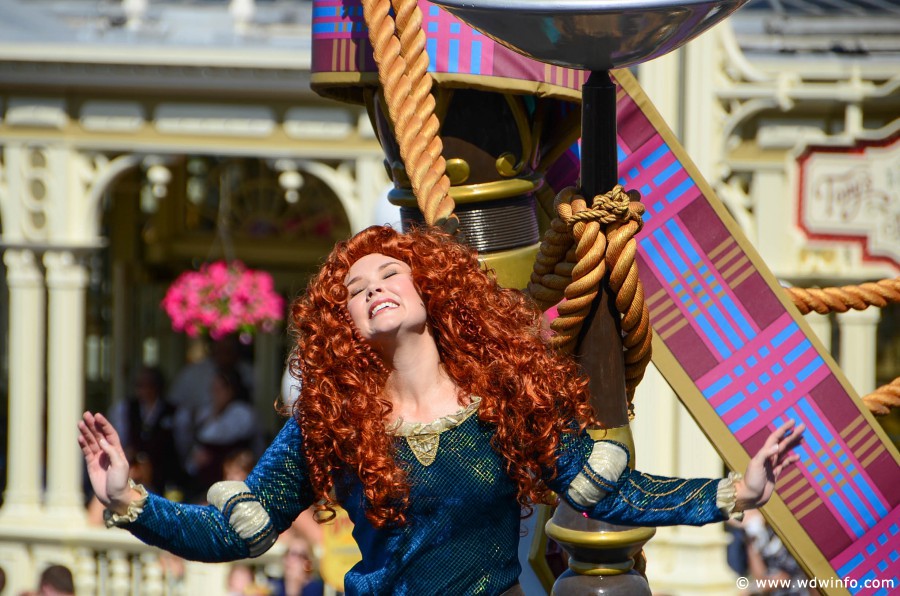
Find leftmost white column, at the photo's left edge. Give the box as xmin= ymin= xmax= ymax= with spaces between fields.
xmin=0 ymin=249 xmax=46 ymax=524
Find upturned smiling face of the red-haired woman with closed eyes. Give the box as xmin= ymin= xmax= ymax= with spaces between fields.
xmin=344 ymin=253 xmax=428 ymax=343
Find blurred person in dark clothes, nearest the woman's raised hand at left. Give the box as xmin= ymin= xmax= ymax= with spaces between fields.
xmin=109 ymin=366 xmax=184 ymax=493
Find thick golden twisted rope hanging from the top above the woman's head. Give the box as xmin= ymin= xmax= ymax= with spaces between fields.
xmin=363 ymin=0 xmax=459 ymax=233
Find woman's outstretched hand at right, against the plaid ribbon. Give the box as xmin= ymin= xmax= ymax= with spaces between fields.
xmin=734 ymin=420 xmax=806 ymax=511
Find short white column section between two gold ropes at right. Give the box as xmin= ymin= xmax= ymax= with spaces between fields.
xmin=837 ymin=308 xmax=881 ymax=395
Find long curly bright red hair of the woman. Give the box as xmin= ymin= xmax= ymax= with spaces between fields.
xmin=290 ymin=226 xmax=593 ymax=528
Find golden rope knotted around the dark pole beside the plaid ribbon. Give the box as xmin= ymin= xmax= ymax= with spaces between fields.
xmin=526 ymin=185 xmax=652 ymax=413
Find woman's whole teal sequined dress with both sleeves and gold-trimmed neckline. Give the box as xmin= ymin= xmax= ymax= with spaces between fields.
xmin=125 ymin=401 xmax=733 ymax=595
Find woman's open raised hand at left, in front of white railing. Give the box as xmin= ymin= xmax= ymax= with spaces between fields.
xmin=78 ymin=412 xmax=141 ymax=515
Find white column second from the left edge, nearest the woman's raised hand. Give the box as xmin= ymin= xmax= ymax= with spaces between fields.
xmin=44 ymin=251 xmax=87 ymax=521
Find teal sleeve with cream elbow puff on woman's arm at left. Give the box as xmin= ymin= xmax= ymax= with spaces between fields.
xmin=125 ymin=419 xmax=314 ymax=562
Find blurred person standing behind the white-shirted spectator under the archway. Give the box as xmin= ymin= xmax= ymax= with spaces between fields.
xmin=168 ymin=335 xmax=254 ymax=459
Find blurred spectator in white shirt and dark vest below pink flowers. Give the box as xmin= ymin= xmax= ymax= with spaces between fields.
xmin=187 ymin=367 xmax=262 ymax=498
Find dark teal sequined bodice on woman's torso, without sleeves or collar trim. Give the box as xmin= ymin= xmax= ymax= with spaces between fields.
xmin=339 ymin=408 xmax=521 ymax=594
